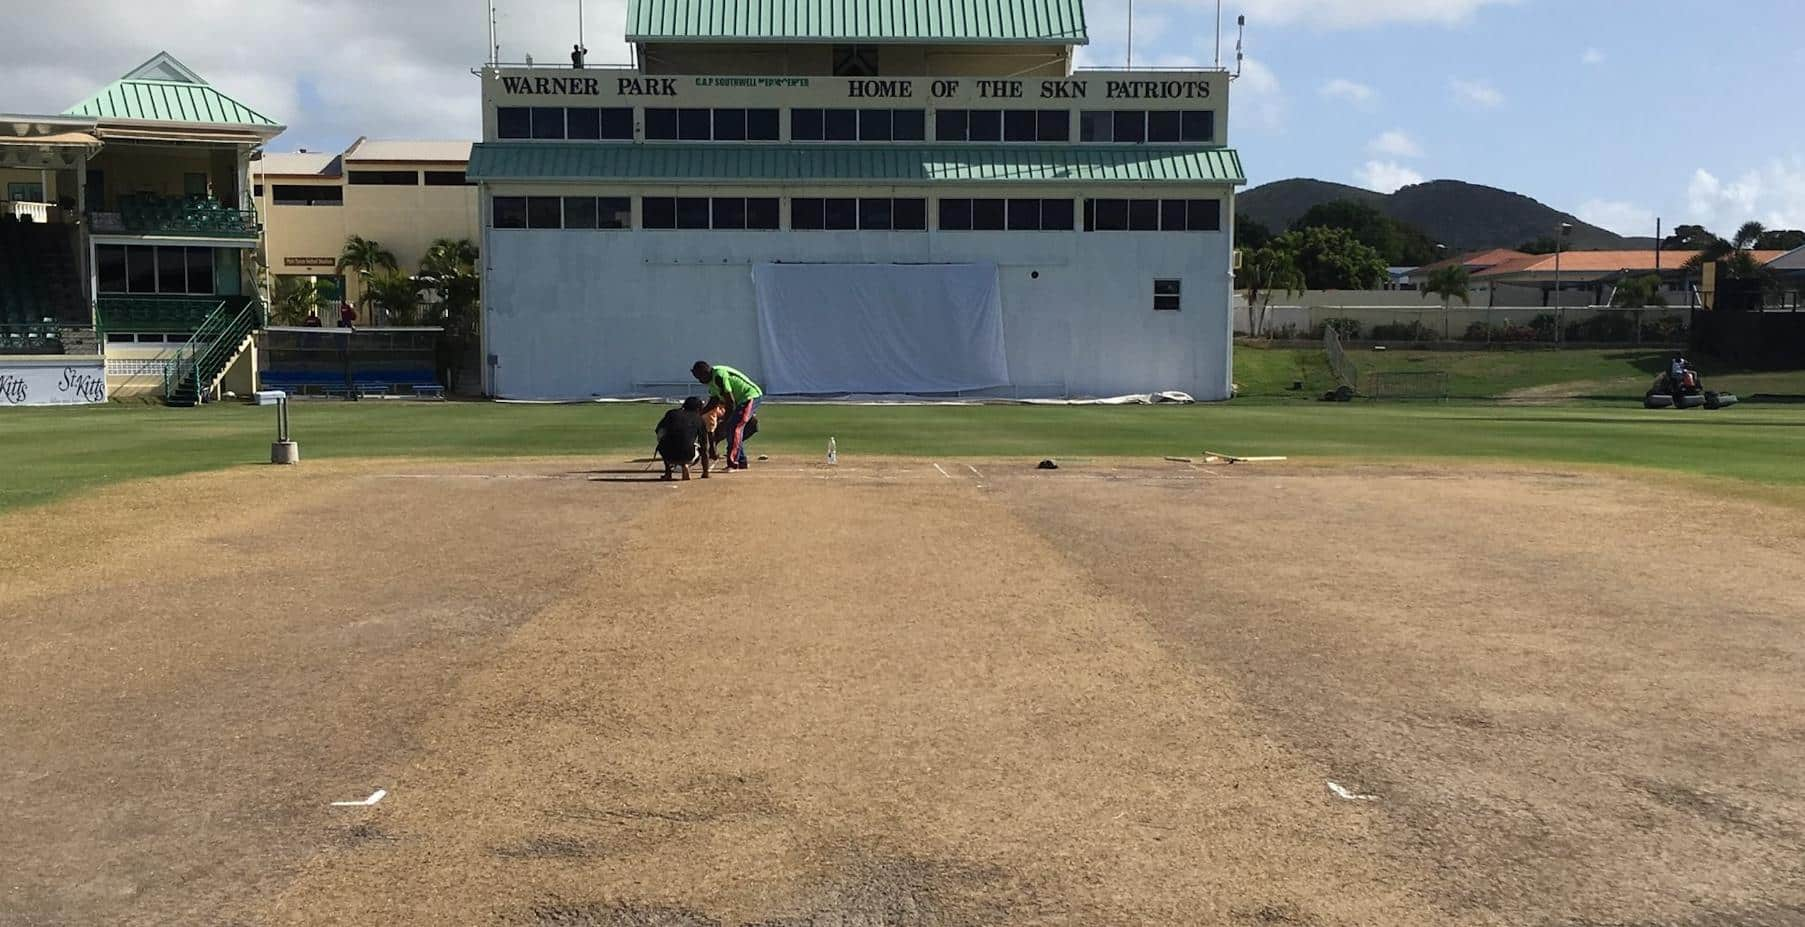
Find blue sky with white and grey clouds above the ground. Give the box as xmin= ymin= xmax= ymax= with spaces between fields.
xmin=0 ymin=0 xmax=1805 ymax=234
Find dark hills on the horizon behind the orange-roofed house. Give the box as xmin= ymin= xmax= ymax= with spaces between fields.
xmin=1235 ymin=179 xmax=1653 ymax=251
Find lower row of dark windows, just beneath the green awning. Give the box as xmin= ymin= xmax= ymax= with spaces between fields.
xmin=491 ymin=197 xmax=1222 ymax=231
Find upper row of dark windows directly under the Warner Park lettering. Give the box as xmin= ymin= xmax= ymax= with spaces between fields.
xmin=501 ymin=106 xmax=1217 ymax=142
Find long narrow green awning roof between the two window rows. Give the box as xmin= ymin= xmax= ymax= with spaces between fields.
xmin=467 ymin=142 xmax=1247 ymax=184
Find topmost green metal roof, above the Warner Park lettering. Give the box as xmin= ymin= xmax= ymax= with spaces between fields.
xmin=626 ymin=0 xmax=1090 ymax=45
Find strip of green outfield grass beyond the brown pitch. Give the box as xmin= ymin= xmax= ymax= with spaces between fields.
xmin=0 ymin=394 xmax=1805 ymax=509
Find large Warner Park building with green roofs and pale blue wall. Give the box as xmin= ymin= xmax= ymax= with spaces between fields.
xmin=469 ymin=0 xmax=1244 ymax=400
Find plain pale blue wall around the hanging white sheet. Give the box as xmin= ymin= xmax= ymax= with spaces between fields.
xmin=484 ymin=229 xmax=1231 ymax=400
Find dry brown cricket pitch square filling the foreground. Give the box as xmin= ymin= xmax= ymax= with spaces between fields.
xmin=0 ymin=462 xmax=1805 ymax=927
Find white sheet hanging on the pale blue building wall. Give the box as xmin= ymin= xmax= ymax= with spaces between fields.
xmin=753 ymin=263 xmax=1009 ymax=395
